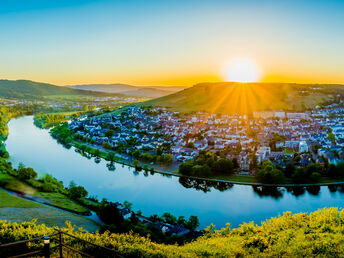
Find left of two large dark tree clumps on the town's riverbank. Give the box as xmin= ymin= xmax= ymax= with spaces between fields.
xmin=179 ymin=151 xmax=239 ymax=177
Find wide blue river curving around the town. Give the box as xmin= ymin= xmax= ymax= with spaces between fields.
xmin=6 ymin=116 xmax=344 ymax=228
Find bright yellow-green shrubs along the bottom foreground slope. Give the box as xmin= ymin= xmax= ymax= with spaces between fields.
xmin=0 ymin=208 xmax=344 ymax=257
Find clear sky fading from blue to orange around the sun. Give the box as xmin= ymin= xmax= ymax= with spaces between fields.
xmin=0 ymin=0 xmax=344 ymax=86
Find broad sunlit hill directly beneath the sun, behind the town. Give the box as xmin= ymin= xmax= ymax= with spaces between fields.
xmin=143 ymin=82 xmax=344 ymax=114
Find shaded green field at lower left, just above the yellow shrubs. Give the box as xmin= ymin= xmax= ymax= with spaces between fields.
xmin=0 ymin=189 xmax=99 ymax=232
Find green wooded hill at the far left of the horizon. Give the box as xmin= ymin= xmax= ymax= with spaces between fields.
xmin=0 ymin=80 xmax=113 ymax=99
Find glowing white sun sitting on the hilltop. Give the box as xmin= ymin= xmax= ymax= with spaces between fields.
xmin=224 ymin=58 xmax=261 ymax=82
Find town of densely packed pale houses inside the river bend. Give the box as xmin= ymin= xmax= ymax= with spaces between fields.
xmin=68 ymin=104 xmax=344 ymax=173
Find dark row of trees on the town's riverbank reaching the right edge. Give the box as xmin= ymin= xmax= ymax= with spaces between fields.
xmin=255 ymin=161 xmax=344 ymax=184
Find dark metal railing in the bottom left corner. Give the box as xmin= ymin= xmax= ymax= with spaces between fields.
xmin=0 ymin=230 xmax=121 ymax=258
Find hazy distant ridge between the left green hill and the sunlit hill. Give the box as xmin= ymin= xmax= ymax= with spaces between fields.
xmin=68 ymin=83 xmax=185 ymax=98
